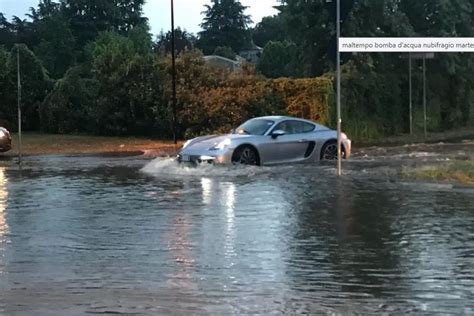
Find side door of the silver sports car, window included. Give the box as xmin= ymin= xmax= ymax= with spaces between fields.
xmin=265 ymin=120 xmax=309 ymax=163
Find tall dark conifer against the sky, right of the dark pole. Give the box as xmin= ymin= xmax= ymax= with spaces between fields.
xmin=198 ymin=0 xmax=252 ymax=54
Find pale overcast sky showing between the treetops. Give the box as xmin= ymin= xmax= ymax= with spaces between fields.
xmin=0 ymin=0 xmax=278 ymax=34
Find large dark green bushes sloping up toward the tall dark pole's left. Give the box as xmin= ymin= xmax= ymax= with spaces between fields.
xmin=41 ymin=28 xmax=162 ymax=135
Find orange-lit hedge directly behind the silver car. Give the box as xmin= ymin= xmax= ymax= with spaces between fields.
xmin=157 ymin=50 xmax=332 ymax=137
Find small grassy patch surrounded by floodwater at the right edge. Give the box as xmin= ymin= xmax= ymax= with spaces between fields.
xmin=402 ymin=157 xmax=474 ymax=184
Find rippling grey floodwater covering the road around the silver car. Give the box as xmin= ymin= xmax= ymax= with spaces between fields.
xmin=0 ymin=143 xmax=474 ymax=315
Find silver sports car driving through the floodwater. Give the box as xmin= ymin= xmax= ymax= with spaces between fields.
xmin=177 ymin=116 xmax=351 ymax=165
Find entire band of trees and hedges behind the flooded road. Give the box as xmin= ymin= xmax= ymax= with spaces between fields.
xmin=0 ymin=0 xmax=474 ymax=139
